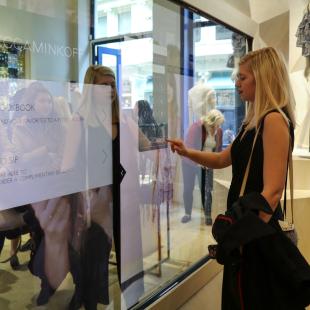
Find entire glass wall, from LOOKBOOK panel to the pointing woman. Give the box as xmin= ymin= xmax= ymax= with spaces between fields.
xmin=0 ymin=0 xmax=247 ymax=309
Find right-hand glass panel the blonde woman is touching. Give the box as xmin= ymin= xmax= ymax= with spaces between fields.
xmin=96 ymin=1 xmax=246 ymax=306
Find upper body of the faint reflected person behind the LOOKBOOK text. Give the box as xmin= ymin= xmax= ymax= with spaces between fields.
xmin=12 ymin=82 xmax=64 ymax=175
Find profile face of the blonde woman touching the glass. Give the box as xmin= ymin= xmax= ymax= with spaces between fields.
xmin=236 ymin=63 xmax=256 ymax=102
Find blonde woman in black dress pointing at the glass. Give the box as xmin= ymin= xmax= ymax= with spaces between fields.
xmin=169 ymin=47 xmax=310 ymax=310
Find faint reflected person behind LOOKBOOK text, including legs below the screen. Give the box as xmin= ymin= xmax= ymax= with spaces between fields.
xmin=10 ymin=82 xmax=67 ymax=304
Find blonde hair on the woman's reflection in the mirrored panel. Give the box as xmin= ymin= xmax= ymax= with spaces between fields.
xmin=82 ymin=65 xmax=119 ymax=124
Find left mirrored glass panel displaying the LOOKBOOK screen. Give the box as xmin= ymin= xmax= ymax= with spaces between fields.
xmin=0 ymin=0 xmax=117 ymax=309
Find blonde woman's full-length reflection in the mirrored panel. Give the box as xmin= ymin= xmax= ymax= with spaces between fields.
xmin=70 ymin=65 xmax=120 ymax=309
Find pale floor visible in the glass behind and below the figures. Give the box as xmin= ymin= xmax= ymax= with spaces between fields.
xmin=0 ymin=170 xmax=226 ymax=310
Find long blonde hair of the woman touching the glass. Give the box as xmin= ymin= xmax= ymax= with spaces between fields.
xmin=239 ymin=47 xmax=295 ymax=129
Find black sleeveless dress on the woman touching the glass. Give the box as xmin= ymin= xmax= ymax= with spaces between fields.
xmin=222 ymin=111 xmax=299 ymax=310
